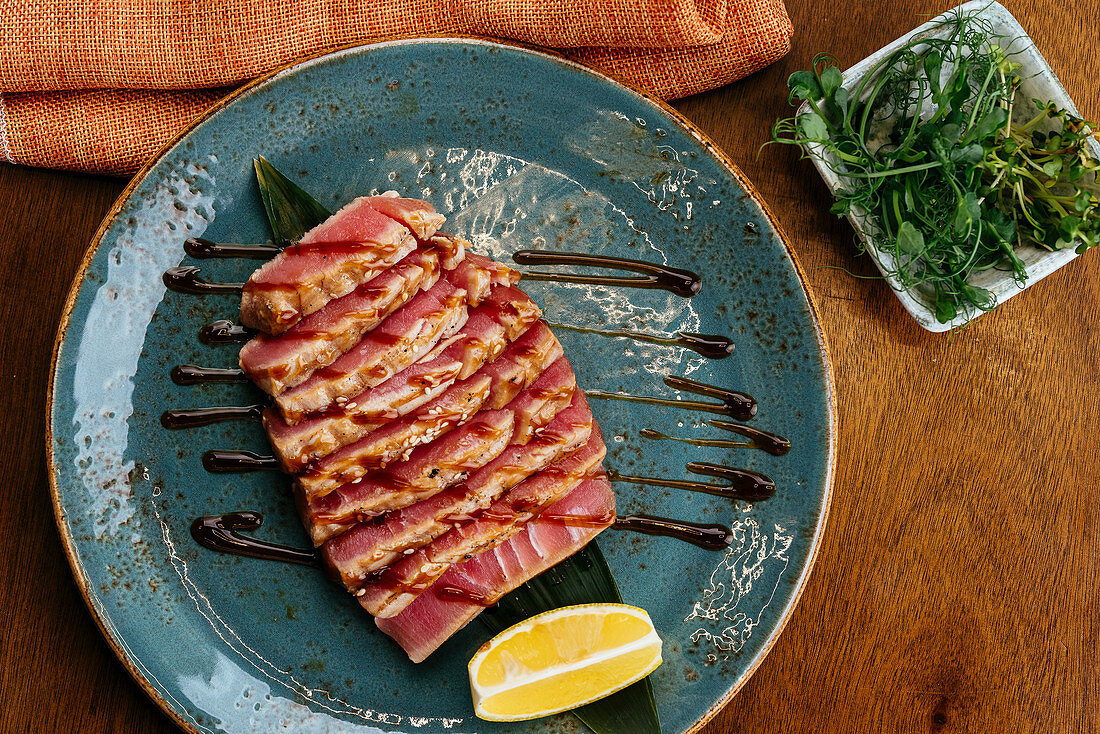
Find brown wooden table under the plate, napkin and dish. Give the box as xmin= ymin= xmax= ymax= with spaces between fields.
xmin=0 ymin=0 xmax=1100 ymax=734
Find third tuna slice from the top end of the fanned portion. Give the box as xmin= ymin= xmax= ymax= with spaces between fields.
xmin=275 ymin=281 xmax=468 ymax=425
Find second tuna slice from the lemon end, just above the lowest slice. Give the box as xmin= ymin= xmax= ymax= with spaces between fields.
xmin=356 ymin=427 xmax=607 ymax=617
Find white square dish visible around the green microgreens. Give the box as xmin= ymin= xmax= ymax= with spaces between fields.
xmin=796 ymin=0 xmax=1100 ymax=331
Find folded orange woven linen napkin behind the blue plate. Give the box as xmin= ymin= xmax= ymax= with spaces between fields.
xmin=0 ymin=0 xmax=791 ymax=174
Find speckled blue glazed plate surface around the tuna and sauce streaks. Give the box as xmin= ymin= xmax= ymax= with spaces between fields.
xmin=47 ymin=39 xmax=834 ymax=732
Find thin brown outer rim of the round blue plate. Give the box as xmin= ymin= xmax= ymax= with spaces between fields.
xmin=45 ymin=33 xmax=838 ymax=734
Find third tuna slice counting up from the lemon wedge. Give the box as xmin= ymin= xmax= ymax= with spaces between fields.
xmin=321 ymin=390 xmax=592 ymax=589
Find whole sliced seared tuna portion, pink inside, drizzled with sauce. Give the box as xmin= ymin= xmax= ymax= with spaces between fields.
xmin=240 ymin=199 xmax=615 ymax=661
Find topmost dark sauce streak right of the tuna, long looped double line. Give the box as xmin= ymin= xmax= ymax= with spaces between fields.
xmin=512 ymin=250 xmax=702 ymax=298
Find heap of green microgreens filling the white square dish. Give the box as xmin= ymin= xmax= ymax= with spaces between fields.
xmin=771 ymin=12 xmax=1100 ymax=324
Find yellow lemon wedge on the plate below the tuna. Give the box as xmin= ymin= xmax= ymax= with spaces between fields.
xmin=470 ymin=604 xmax=661 ymax=721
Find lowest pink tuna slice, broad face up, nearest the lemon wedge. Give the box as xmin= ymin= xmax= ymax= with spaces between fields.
xmin=375 ymin=479 xmax=615 ymax=662
